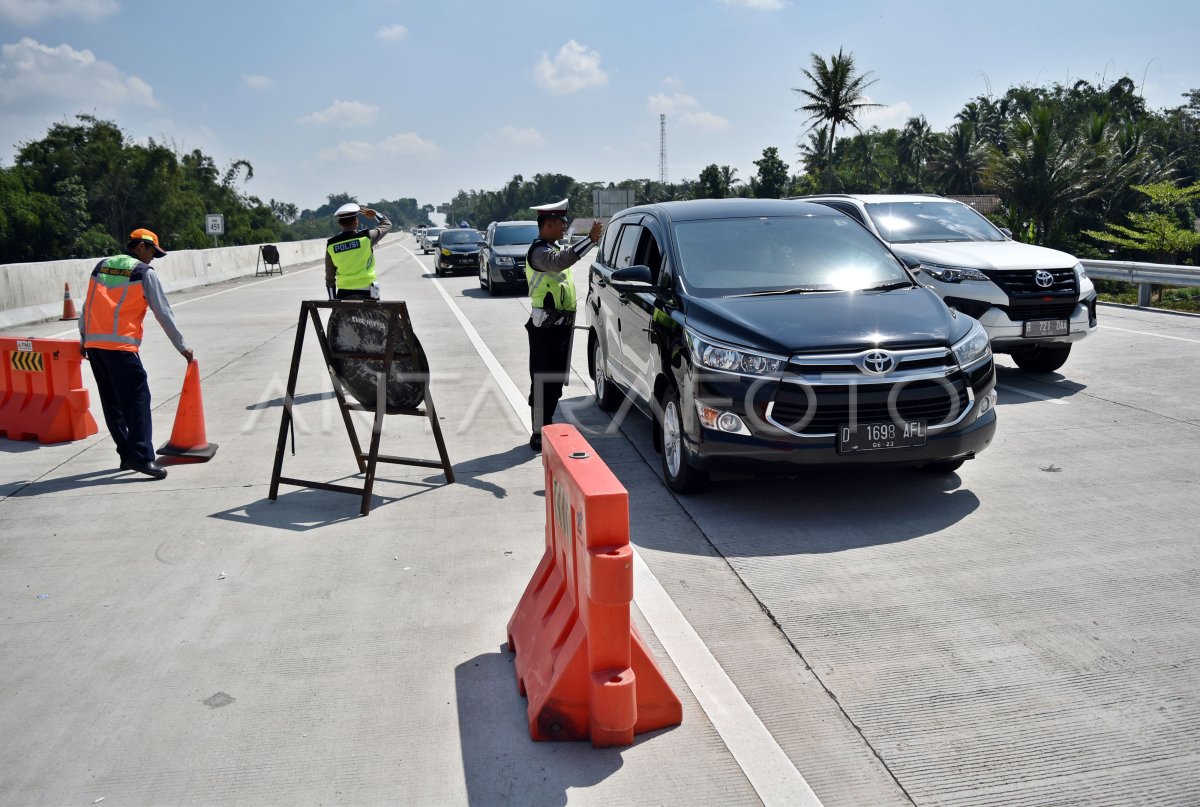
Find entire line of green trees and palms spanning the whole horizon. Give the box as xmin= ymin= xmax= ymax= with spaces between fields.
xmin=0 ymin=50 xmax=1200 ymax=263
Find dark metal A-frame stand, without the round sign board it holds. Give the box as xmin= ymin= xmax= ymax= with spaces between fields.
xmin=269 ymin=300 xmax=454 ymax=515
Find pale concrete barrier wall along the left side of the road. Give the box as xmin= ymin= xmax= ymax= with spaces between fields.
xmin=0 ymin=238 xmax=325 ymax=328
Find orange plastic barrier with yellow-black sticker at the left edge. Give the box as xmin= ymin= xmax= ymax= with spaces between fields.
xmin=0 ymin=336 xmax=97 ymax=443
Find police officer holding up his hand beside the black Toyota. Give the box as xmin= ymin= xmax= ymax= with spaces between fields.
xmin=526 ymin=199 xmax=600 ymax=452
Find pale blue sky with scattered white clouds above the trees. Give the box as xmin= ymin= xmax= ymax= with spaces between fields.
xmin=0 ymin=0 xmax=1200 ymax=225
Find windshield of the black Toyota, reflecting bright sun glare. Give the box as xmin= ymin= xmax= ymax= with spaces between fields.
xmin=676 ymin=216 xmax=911 ymax=297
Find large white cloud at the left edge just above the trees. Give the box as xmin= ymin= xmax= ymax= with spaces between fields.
xmin=0 ymin=36 xmax=158 ymax=114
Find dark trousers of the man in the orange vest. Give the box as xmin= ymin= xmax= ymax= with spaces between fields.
xmin=88 ymin=347 xmax=155 ymax=464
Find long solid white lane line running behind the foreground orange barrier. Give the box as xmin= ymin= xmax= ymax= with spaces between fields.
xmin=417 ymin=246 xmax=821 ymax=807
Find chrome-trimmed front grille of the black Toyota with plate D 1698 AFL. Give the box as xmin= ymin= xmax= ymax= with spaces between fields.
xmin=767 ymin=348 xmax=973 ymax=437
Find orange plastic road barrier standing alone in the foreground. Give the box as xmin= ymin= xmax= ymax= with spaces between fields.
xmin=509 ymin=424 xmax=683 ymax=747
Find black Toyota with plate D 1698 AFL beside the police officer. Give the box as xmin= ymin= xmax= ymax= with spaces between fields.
xmin=587 ymin=199 xmax=996 ymax=492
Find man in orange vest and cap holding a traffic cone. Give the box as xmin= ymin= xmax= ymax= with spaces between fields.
xmin=79 ymin=228 xmax=192 ymax=479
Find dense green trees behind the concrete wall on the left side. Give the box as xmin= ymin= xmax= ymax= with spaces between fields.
xmin=0 ymin=115 xmax=433 ymax=263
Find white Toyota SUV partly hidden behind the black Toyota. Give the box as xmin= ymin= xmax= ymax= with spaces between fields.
xmin=797 ymin=193 xmax=1096 ymax=372
